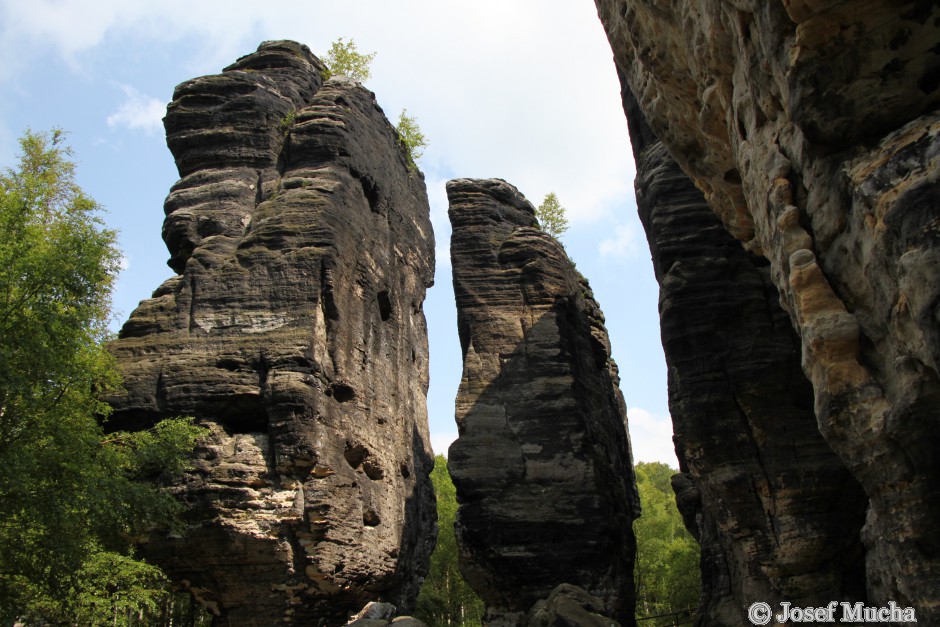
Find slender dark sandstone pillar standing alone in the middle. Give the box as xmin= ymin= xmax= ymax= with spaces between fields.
xmin=447 ymin=179 xmax=639 ymax=625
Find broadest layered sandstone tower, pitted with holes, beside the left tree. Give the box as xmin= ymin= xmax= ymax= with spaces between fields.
xmin=111 ymin=42 xmax=436 ymax=625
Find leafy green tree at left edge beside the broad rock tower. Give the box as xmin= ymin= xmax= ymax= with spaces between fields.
xmin=0 ymin=130 xmax=201 ymax=624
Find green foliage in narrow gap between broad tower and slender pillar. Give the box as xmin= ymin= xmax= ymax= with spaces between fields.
xmin=415 ymin=455 xmax=484 ymax=627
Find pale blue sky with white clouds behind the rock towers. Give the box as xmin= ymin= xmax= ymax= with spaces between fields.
xmin=0 ymin=0 xmax=676 ymax=466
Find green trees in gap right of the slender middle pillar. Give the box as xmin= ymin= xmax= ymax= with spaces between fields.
xmin=633 ymin=462 xmax=701 ymax=625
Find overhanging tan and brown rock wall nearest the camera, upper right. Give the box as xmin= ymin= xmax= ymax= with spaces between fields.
xmin=596 ymin=0 xmax=940 ymax=623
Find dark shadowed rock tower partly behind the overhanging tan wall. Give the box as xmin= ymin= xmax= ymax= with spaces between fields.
xmin=624 ymin=82 xmax=867 ymax=625
